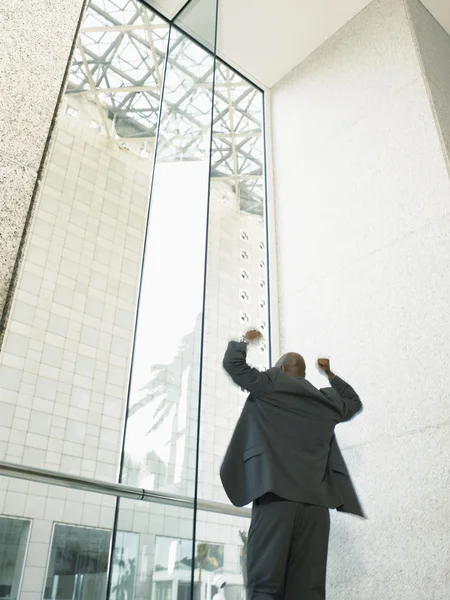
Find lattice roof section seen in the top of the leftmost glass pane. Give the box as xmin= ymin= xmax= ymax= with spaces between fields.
xmin=67 ymin=0 xmax=169 ymax=147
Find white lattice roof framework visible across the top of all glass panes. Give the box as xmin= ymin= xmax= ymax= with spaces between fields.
xmin=67 ymin=0 xmax=264 ymax=215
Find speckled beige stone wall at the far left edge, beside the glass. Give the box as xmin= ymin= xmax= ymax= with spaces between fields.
xmin=0 ymin=0 xmax=83 ymax=336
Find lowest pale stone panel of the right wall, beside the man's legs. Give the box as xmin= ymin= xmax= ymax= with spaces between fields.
xmin=328 ymin=423 xmax=450 ymax=600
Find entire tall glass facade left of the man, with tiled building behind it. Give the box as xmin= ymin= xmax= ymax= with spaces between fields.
xmin=0 ymin=0 xmax=270 ymax=600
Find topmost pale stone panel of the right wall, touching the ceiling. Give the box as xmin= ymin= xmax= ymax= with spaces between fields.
xmin=272 ymin=0 xmax=420 ymax=155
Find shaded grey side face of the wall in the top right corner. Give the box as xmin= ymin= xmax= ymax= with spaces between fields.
xmin=408 ymin=0 xmax=450 ymax=168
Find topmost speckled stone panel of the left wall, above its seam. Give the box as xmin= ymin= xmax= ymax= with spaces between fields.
xmin=0 ymin=0 xmax=83 ymax=170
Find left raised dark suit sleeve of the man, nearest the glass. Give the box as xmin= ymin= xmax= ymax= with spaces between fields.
xmin=222 ymin=342 xmax=273 ymax=396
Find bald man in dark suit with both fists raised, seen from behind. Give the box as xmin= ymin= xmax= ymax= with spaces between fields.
xmin=220 ymin=331 xmax=364 ymax=600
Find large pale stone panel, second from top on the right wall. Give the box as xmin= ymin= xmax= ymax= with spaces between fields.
xmin=275 ymin=78 xmax=450 ymax=298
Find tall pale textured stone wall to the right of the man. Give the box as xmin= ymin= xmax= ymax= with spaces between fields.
xmin=272 ymin=0 xmax=450 ymax=600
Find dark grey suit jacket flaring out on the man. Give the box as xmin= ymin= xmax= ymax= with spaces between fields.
xmin=220 ymin=342 xmax=364 ymax=516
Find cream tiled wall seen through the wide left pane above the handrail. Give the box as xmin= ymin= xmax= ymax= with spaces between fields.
xmin=0 ymin=95 xmax=151 ymax=479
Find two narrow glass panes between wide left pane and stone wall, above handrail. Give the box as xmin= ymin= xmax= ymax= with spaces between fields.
xmin=118 ymin=8 xmax=268 ymax=500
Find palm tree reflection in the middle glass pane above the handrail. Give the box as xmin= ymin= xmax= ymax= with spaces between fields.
xmin=124 ymin=314 xmax=202 ymax=493
